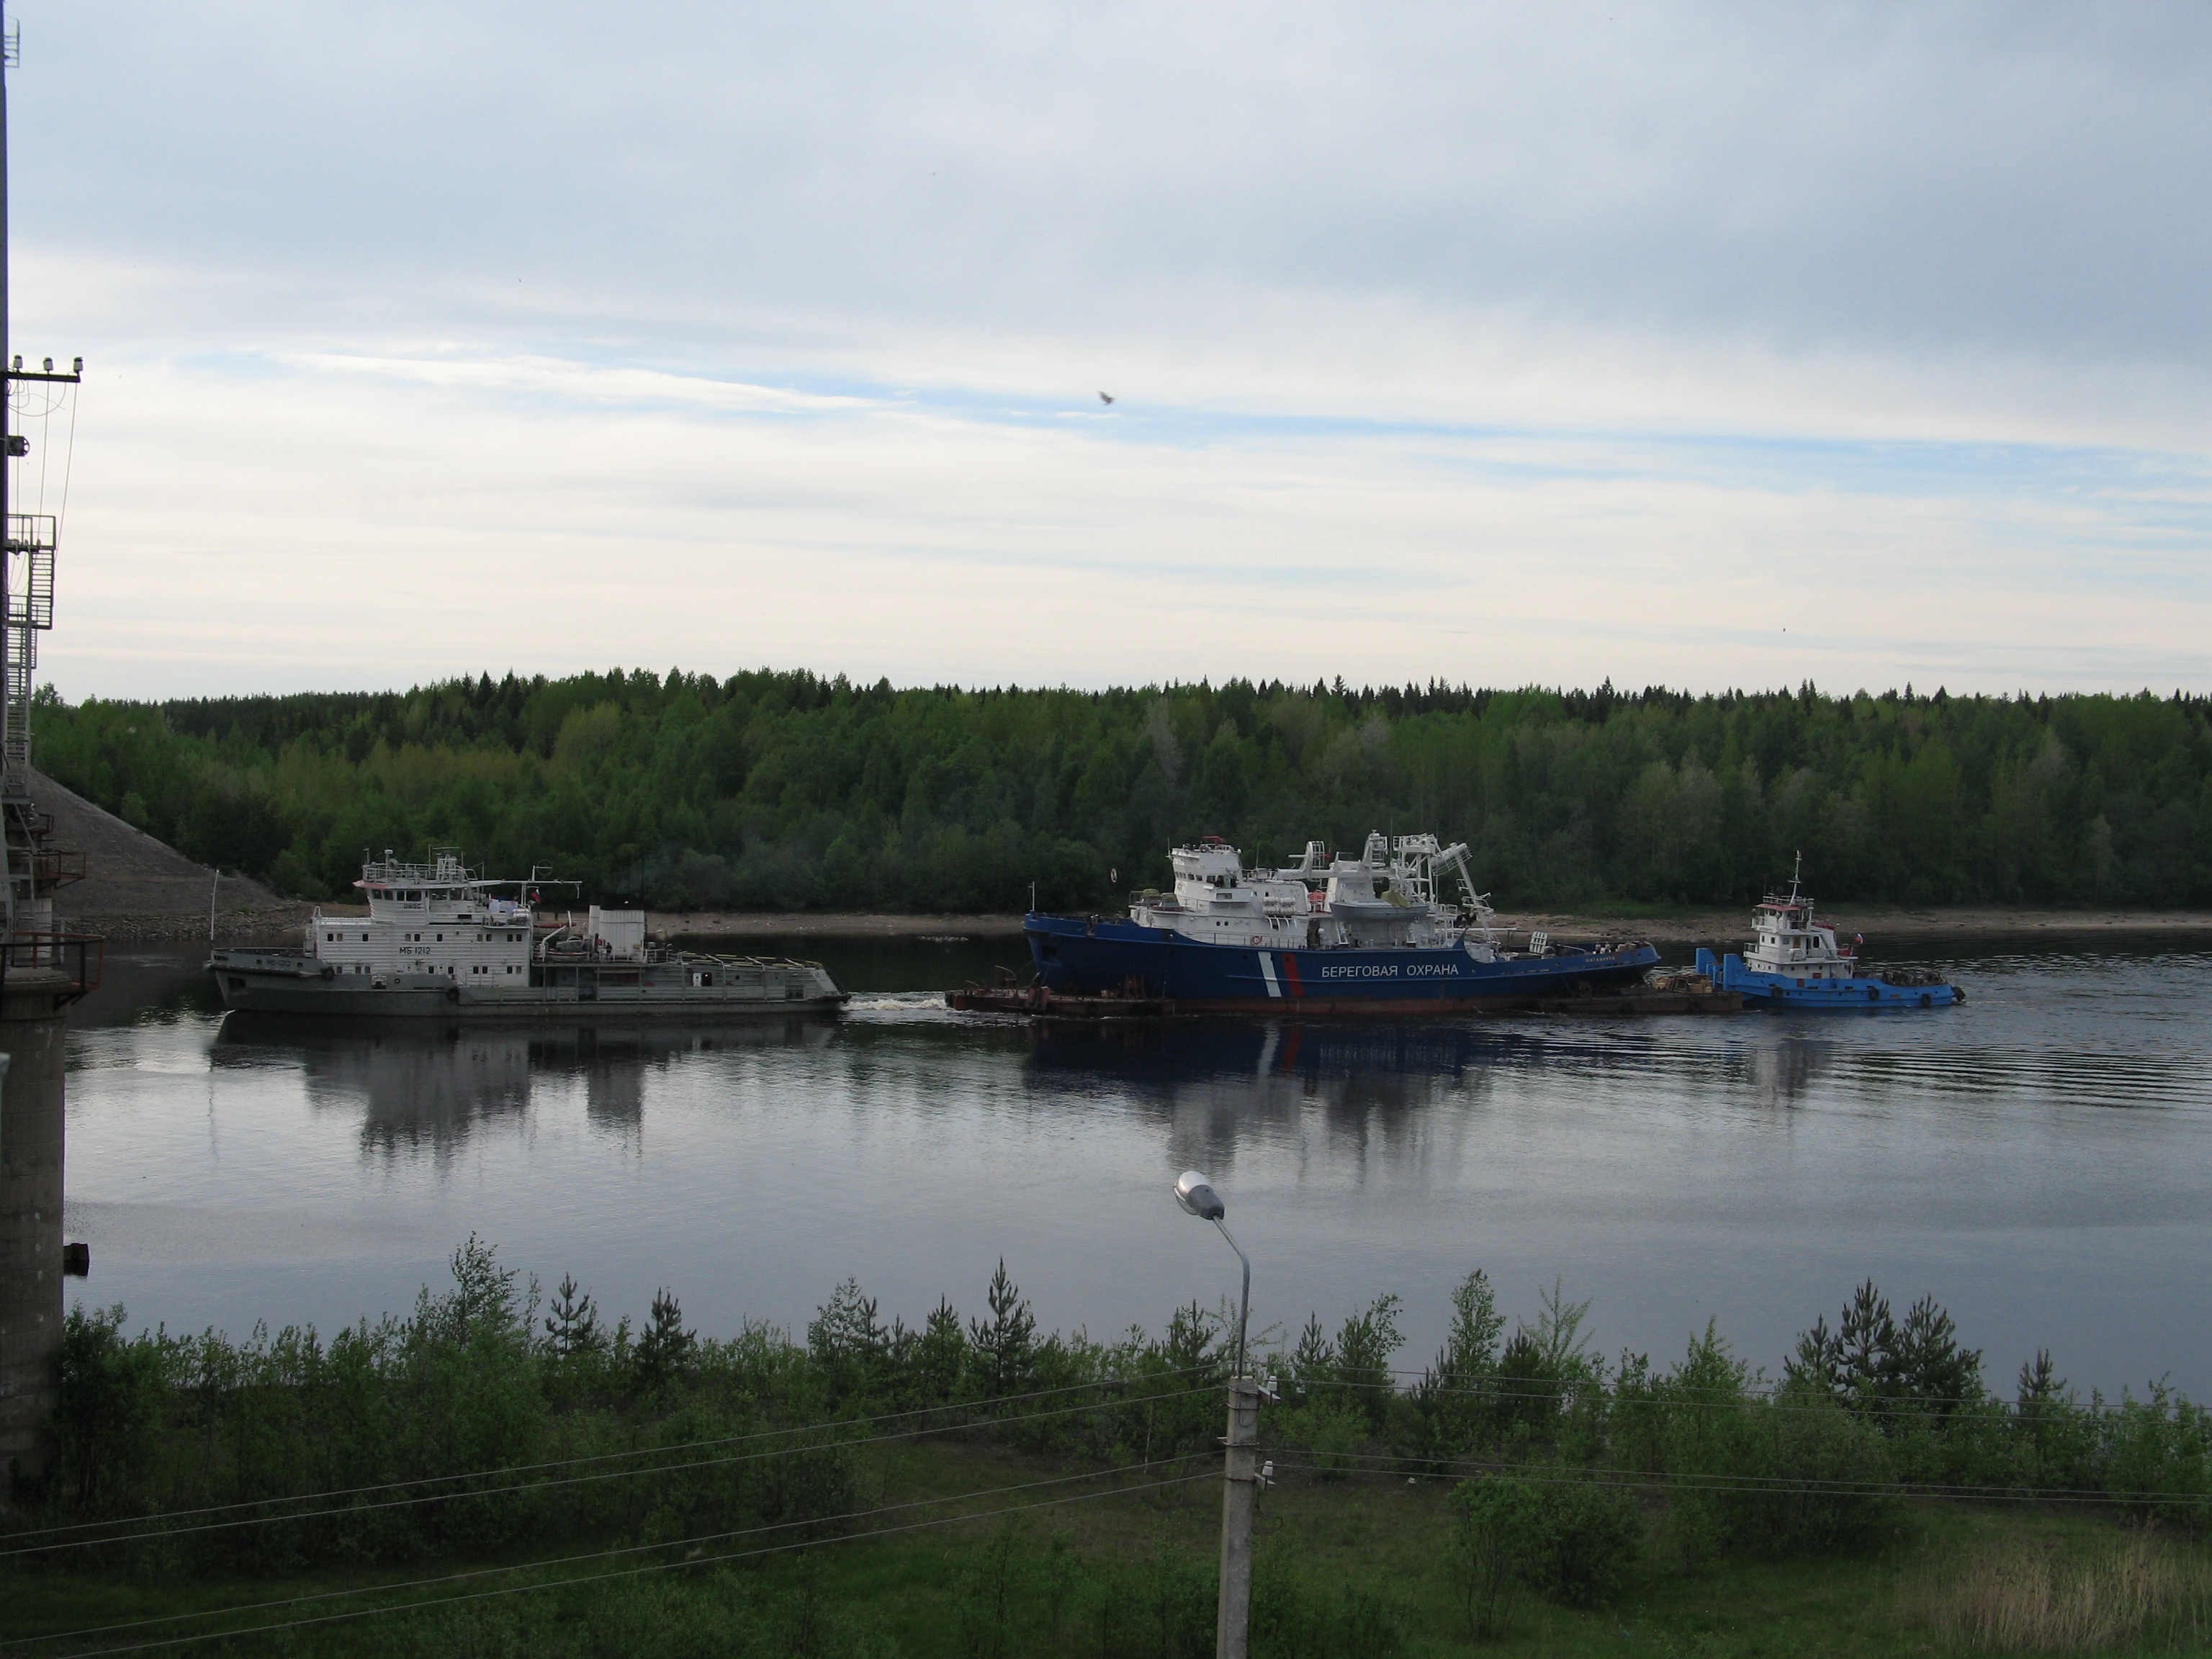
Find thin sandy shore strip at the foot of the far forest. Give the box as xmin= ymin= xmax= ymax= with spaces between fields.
xmin=648 ymin=904 xmax=2212 ymax=945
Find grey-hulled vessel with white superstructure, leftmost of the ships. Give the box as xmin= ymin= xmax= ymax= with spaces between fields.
xmin=208 ymin=848 xmax=845 ymax=1020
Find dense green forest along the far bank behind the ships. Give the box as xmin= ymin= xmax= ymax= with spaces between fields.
xmin=21 ymin=670 xmax=2212 ymax=912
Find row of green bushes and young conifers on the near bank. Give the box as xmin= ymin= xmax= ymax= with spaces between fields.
xmin=26 ymin=1238 xmax=2212 ymax=1655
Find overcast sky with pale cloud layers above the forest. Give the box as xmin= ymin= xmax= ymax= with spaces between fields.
xmin=9 ymin=0 xmax=2212 ymax=699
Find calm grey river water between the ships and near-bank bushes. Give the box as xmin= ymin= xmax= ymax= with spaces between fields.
xmin=52 ymin=940 xmax=2212 ymax=1398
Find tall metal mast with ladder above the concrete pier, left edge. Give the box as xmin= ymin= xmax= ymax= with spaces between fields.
xmin=0 ymin=22 xmax=84 ymax=935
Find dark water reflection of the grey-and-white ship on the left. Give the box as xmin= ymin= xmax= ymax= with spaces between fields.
xmin=210 ymin=1013 xmax=836 ymax=1157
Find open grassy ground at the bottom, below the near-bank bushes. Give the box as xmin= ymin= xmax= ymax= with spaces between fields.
xmin=17 ymin=1444 xmax=2212 ymax=1659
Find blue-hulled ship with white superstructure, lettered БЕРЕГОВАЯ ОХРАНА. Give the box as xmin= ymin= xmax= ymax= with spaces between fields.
xmin=1022 ymin=834 xmax=1659 ymax=1013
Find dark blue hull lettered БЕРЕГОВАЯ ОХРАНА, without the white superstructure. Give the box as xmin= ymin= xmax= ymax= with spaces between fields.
xmin=1022 ymin=916 xmax=1659 ymax=1015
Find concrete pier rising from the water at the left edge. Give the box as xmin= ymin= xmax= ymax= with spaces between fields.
xmin=0 ymin=969 xmax=73 ymax=1498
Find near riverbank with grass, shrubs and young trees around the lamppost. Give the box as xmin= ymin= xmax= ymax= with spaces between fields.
xmin=13 ymin=1238 xmax=2212 ymax=1659
